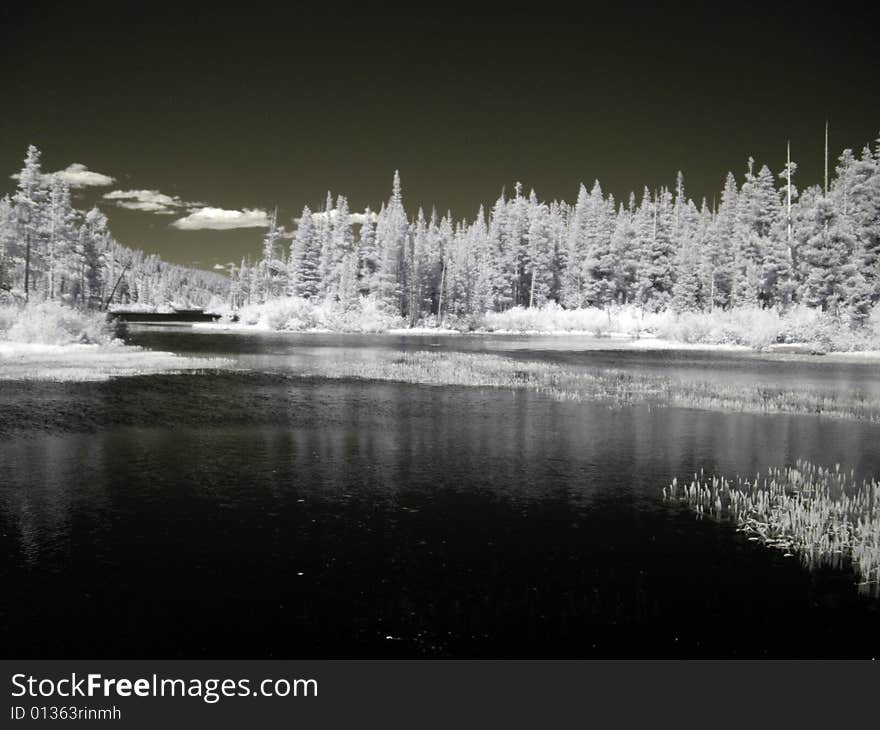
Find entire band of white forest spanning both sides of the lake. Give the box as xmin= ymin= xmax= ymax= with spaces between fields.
xmin=6 ymin=133 xmax=880 ymax=327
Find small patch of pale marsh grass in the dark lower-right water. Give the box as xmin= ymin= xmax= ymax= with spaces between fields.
xmin=662 ymin=460 xmax=880 ymax=598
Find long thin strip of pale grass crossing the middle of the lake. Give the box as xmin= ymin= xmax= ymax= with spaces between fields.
xmin=315 ymin=351 xmax=880 ymax=423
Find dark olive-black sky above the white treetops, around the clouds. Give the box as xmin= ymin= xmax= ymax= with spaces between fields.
xmin=0 ymin=2 xmax=880 ymax=268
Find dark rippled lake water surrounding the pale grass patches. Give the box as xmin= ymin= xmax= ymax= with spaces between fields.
xmin=0 ymin=330 xmax=880 ymax=658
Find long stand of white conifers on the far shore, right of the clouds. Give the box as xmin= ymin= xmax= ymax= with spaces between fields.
xmin=235 ymin=134 xmax=880 ymax=327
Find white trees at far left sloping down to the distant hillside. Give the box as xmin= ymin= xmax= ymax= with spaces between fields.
xmin=0 ymin=145 xmax=229 ymax=308
